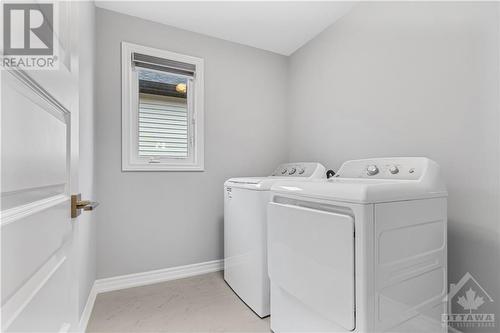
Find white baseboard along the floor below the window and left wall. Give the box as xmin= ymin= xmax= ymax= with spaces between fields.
xmin=80 ymin=259 xmax=224 ymax=332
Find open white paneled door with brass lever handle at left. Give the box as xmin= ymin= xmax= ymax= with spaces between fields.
xmin=1 ymin=3 xmax=78 ymax=332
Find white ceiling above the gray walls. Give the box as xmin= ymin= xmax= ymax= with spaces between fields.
xmin=96 ymin=1 xmax=354 ymax=55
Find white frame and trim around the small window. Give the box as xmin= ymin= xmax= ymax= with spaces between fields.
xmin=122 ymin=42 xmax=204 ymax=171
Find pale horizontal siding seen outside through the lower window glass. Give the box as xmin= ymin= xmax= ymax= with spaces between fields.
xmin=139 ymin=99 xmax=188 ymax=158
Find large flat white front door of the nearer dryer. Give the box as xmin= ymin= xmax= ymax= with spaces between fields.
xmin=268 ymin=203 xmax=355 ymax=330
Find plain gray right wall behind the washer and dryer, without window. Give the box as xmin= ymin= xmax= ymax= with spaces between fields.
xmin=288 ymin=3 xmax=500 ymax=331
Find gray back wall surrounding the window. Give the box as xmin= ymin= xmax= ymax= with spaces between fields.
xmin=96 ymin=9 xmax=287 ymax=278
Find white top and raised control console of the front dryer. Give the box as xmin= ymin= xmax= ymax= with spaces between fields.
xmin=272 ymin=157 xmax=447 ymax=204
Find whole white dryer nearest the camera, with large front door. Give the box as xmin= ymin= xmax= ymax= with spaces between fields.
xmin=268 ymin=158 xmax=447 ymax=333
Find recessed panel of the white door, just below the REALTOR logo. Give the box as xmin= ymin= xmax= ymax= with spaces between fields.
xmin=1 ymin=74 xmax=69 ymax=198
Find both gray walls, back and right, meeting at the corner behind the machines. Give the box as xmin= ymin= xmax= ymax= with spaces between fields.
xmin=96 ymin=3 xmax=500 ymax=324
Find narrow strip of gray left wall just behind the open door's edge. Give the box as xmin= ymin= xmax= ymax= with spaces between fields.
xmin=75 ymin=1 xmax=97 ymax=315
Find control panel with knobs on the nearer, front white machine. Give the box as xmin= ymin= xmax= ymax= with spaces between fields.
xmin=334 ymin=157 xmax=428 ymax=180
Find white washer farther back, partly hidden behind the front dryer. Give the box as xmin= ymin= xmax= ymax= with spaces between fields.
xmin=224 ymin=163 xmax=325 ymax=317
